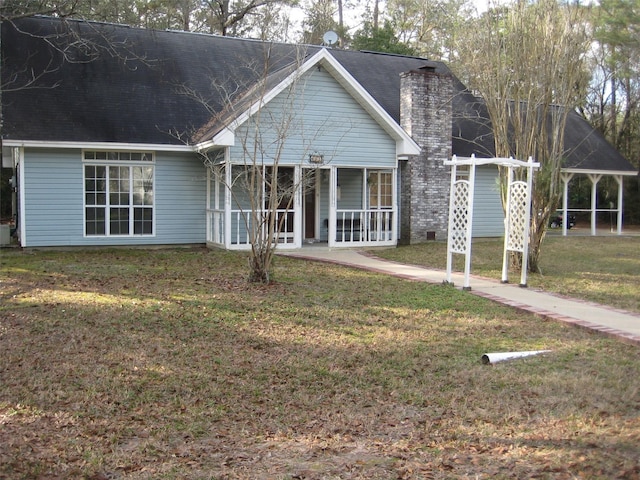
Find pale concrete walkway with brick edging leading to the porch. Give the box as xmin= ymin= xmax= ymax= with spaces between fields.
xmin=279 ymin=247 xmax=640 ymax=345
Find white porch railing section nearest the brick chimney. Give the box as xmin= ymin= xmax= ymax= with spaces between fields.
xmin=327 ymin=210 xmax=395 ymax=245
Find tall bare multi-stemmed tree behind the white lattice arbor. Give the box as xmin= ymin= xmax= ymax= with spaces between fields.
xmin=458 ymin=0 xmax=590 ymax=271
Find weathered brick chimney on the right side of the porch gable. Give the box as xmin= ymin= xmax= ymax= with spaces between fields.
xmin=400 ymin=66 xmax=453 ymax=244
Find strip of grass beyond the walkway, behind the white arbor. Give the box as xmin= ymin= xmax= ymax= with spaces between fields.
xmin=375 ymin=235 xmax=640 ymax=313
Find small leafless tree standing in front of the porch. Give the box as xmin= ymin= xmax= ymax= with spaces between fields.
xmin=180 ymin=47 xmax=350 ymax=283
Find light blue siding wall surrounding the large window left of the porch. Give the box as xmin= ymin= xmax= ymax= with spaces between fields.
xmin=21 ymin=149 xmax=206 ymax=247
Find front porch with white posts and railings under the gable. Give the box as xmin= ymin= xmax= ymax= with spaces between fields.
xmin=207 ymin=165 xmax=398 ymax=250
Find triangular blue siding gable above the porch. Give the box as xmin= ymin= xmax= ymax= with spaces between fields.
xmin=231 ymin=69 xmax=396 ymax=168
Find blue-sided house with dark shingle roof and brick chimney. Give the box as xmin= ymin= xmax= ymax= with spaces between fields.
xmin=2 ymin=17 xmax=637 ymax=249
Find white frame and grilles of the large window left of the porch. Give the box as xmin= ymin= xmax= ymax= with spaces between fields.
xmin=82 ymin=150 xmax=156 ymax=238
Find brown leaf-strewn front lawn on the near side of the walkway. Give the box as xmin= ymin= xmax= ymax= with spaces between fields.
xmin=0 ymin=246 xmax=640 ymax=479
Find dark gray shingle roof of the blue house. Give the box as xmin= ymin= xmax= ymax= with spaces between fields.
xmin=2 ymin=17 xmax=633 ymax=171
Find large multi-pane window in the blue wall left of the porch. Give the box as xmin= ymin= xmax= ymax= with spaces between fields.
xmin=84 ymin=152 xmax=154 ymax=236
